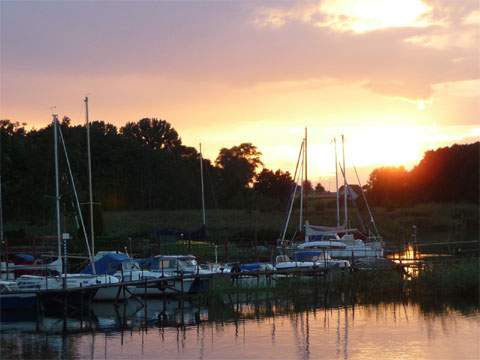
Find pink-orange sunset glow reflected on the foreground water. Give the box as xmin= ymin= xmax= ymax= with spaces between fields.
xmin=69 ymin=304 xmax=480 ymax=359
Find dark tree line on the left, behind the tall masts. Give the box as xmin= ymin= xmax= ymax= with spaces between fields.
xmin=0 ymin=117 xmax=294 ymax=228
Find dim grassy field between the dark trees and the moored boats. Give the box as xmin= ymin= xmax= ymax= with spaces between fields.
xmin=7 ymin=198 xmax=479 ymax=259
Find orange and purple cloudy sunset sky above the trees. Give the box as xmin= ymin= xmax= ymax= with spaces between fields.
xmin=0 ymin=0 xmax=480 ymax=187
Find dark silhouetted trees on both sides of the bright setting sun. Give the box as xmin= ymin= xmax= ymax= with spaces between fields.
xmin=0 ymin=117 xmax=480 ymax=231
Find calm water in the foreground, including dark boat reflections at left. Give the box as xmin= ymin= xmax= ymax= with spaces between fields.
xmin=0 ymin=298 xmax=480 ymax=360
